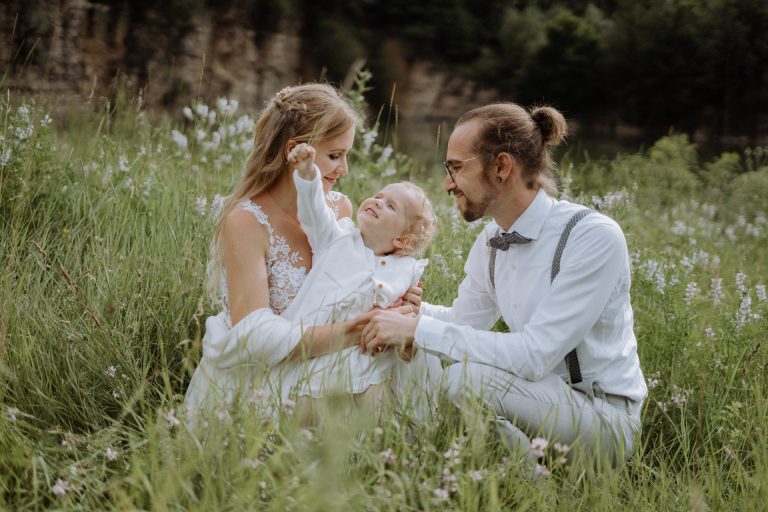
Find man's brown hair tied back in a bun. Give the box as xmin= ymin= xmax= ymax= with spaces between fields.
xmin=456 ymin=103 xmax=568 ymax=195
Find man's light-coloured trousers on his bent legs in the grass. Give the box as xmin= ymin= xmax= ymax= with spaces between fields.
xmin=443 ymin=363 xmax=642 ymax=464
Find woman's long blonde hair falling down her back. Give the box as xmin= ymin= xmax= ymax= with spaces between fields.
xmin=207 ymin=84 xmax=357 ymax=305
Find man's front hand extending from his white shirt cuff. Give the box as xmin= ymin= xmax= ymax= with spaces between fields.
xmin=360 ymin=305 xmax=419 ymax=361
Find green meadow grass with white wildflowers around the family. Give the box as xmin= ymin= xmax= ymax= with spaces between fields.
xmin=0 ymin=82 xmax=768 ymax=511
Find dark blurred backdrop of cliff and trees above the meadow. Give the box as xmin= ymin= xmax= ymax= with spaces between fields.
xmin=0 ymin=0 xmax=768 ymax=165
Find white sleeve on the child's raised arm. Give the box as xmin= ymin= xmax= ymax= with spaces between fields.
xmin=293 ymin=165 xmax=344 ymax=252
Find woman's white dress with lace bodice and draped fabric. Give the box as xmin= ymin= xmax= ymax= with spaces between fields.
xmin=184 ymin=193 xmax=343 ymax=420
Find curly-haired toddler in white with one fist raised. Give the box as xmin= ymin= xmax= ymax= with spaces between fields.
xmin=282 ymin=144 xmax=435 ymax=398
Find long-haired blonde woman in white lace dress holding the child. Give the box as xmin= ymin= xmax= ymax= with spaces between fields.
xmin=185 ymin=84 xmax=440 ymax=426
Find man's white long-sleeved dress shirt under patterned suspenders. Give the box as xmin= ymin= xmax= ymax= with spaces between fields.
xmin=414 ymin=190 xmax=647 ymax=401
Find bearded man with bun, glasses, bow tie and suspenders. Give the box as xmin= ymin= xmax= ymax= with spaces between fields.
xmin=362 ymin=103 xmax=647 ymax=461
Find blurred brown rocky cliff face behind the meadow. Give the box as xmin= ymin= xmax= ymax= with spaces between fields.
xmin=0 ymin=0 xmax=495 ymax=122
